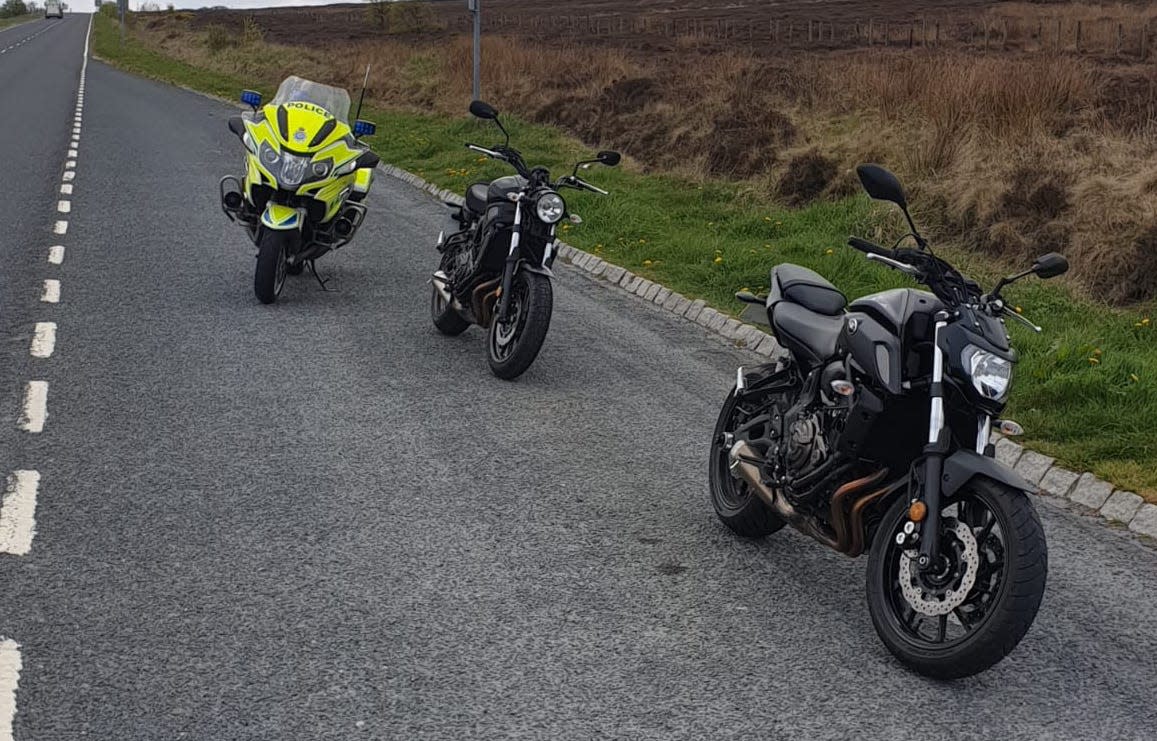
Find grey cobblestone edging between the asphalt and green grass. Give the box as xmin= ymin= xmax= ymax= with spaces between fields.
xmin=381 ymin=164 xmax=1157 ymax=540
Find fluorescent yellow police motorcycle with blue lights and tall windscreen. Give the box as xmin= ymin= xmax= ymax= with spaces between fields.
xmin=221 ymin=76 xmax=378 ymax=303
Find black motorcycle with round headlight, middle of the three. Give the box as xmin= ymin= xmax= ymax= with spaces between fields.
xmin=430 ymin=101 xmax=620 ymax=380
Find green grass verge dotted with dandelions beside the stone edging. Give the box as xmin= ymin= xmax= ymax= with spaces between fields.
xmin=94 ymin=17 xmax=1157 ymax=501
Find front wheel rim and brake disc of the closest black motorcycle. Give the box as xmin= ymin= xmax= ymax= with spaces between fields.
xmin=880 ymin=493 xmax=1010 ymax=651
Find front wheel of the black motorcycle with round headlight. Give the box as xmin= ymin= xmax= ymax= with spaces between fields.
xmin=486 ymin=270 xmax=554 ymax=381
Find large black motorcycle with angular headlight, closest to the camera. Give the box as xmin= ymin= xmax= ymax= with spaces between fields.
xmin=709 ymin=164 xmax=1068 ymax=678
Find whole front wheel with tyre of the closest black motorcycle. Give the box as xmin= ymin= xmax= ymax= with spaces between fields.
xmin=868 ymin=479 xmax=1048 ymax=680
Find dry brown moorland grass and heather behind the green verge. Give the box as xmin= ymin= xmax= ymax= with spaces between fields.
xmin=133 ymin=3 xmax=1157 ymax=303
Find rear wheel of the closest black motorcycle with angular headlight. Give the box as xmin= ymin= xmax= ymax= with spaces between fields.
xmin=707 ymin=389 xmax=787 ymax=538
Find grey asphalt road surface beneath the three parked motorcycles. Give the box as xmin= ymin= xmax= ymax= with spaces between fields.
xmin=0 ymin=16 xmax=1157 ymax=740
